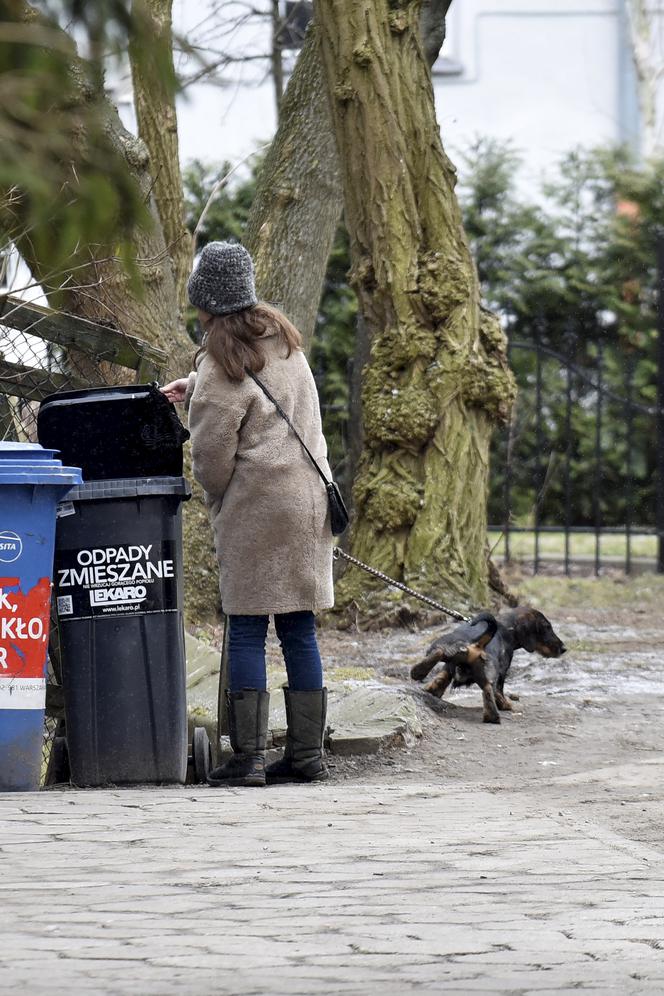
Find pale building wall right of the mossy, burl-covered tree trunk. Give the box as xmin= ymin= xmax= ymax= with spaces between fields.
xmin=435 ymin=0 xmax=638 ymax=182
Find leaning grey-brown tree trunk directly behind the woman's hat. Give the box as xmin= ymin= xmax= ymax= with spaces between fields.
xmin=245 ymin=25 xmax=342 ymax=350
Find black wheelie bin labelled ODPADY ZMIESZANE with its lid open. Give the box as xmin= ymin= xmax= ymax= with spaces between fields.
xmin=38 ymin=385 xmax=202 ymax=786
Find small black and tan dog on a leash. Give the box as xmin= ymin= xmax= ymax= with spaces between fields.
xmin=410 ymin=605 xmax=567 ymax=723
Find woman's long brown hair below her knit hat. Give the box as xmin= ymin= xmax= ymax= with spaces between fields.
xmin=194 ymin=301 xmax=302 ymax=381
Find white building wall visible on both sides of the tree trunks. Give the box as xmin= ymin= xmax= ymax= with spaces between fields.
xmin=156 ymin=0 xmax=638 ymax=196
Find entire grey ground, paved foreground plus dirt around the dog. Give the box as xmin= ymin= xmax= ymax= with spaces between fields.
xmin=5 ymin=588 xmax=664 ymax=996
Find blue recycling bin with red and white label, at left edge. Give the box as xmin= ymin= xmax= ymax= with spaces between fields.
xmin=0 ymin=442 xmax=81 ymax=792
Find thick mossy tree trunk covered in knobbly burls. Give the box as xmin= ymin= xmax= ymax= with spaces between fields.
xmin=315 ymin=0 xmax=514 ymax=605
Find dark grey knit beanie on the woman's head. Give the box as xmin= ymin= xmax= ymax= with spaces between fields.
xmin=187 ymin=242 xmax=258 ymax=315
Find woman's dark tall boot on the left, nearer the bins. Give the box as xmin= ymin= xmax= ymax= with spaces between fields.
xmin=208 ymin=688 xmax=270 ymax=785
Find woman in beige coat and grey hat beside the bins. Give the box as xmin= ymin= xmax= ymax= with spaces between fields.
xmin=163 ymin=242 xmax=334 ymax=785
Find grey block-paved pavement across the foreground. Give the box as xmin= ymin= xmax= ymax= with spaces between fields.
xmin=0 ymin=784 xmax=664 ymax=996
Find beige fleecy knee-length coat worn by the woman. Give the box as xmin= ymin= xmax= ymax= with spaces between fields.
xmin=188 ymin=335 xmax=334 ymax=615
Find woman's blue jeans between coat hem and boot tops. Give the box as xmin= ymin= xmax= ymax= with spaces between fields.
xmin=228 ymin=612 xmax=323 ymax=692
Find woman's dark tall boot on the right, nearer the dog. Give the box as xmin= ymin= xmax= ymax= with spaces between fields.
xmin=265 ymin=688 xmax=330 ymax=785
